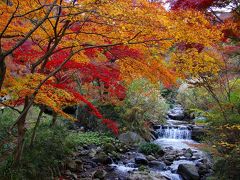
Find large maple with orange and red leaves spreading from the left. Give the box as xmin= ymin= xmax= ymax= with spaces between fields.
xmin=0 ymin=0 xmax=227 ymax=161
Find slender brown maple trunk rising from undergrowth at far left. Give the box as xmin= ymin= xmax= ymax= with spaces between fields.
xmin=14 ymin=96 xmax=29 ymax=165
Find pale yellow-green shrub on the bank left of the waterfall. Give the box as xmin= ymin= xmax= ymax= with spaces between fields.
xmin=120 ymin=79 xmax=169 ymax=140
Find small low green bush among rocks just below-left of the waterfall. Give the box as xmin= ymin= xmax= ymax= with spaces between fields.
xmin=139 ymin=143 xmax=162 ymax=155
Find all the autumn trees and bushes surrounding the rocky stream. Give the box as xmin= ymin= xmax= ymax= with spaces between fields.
xmin=0 ymin=0 xmax=240 ymax=179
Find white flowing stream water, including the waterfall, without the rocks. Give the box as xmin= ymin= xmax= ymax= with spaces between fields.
xmin=110 ymin=105 xmax=204 ymax=180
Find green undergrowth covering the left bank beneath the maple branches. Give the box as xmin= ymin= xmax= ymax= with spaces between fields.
xmin=0 ymin=107 xmax=115 ymax=180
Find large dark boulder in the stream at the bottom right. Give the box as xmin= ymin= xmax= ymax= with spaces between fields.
xmin=177 ymin=164 xmax=200 ymax=180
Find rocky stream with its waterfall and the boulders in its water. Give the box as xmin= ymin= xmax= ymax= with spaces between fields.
xmin=109 ymin=105 xmax=211 ymax=180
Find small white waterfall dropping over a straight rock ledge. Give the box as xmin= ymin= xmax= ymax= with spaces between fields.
xmin=157 ymin=126 xmax=191 ymax=139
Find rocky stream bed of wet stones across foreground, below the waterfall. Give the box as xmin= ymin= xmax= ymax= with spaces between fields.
xmin=62 ymin=143 xmax=212 ymax=180
